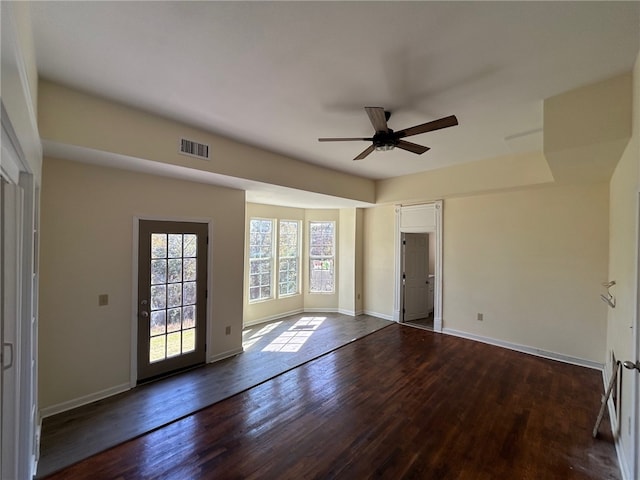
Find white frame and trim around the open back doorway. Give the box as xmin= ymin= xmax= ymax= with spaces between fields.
xmin=393 ymin=200 xmax=443 ymax=332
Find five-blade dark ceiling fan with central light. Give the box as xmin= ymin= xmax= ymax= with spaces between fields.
xmin=318 ymin=107 xmax=458 ymax=160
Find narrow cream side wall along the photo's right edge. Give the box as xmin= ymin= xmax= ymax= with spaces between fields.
xmin=606 ymin=49 xmax=640 ymax=472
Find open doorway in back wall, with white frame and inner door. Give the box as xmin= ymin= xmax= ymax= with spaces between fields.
xmin=394 ymin=201 xmax=442 ymax=332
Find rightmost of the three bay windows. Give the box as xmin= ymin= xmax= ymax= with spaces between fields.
xmin=309 ymin=222 xmax=335 ymax=293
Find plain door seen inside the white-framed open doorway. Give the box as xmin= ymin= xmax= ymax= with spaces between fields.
xmin=402 ymin=233 xmax=429 ymax=322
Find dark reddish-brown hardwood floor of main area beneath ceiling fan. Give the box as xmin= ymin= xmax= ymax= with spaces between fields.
xmin=41 ymin=324 xmax=620 ymax=480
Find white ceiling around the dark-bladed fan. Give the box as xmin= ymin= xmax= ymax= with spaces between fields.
xmin=31 ymin=1 xmax=640 ymax=183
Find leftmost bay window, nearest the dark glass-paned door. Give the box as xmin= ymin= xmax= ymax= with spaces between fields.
xmin=249 ymin=218 xmax=274 ymax=302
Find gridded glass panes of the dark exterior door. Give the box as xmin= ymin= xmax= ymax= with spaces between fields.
xmin=149 ymin=233 xmax=197 ymax=363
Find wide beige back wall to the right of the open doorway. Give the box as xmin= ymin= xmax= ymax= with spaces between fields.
xmin=443 ymin=184 xmax=608 ymax=363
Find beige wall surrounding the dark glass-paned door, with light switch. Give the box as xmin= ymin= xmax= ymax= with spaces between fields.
xmin=39 ymin=158 xmax=245 ymax=408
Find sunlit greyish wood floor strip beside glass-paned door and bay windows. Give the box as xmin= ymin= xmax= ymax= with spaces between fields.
xmin=37 ymin=313 xmax=392 ymax=478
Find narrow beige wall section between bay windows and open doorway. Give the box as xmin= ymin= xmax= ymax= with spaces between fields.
xmin=363 ymin=205 xmax=395 ymax=320
